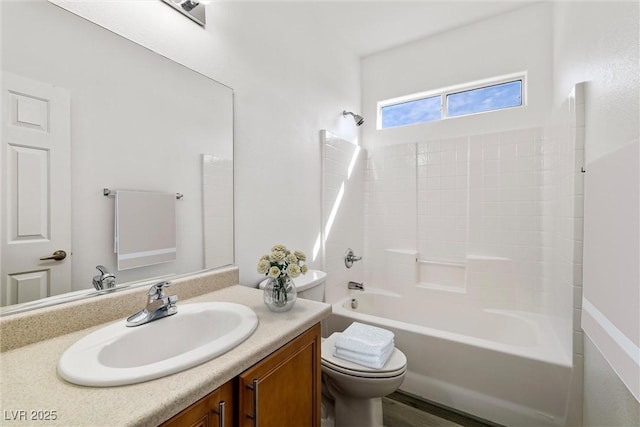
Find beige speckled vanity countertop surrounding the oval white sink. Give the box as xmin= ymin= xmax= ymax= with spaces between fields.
xmin=0 ymin=285 xmax=331 ymax=427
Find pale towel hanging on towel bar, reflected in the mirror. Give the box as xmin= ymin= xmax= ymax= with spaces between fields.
xmin=115 ymin=191 xmax=176 ymax=270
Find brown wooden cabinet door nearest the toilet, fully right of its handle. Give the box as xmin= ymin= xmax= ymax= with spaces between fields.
xmin=238 ymin=324 xmax=321 ymax=427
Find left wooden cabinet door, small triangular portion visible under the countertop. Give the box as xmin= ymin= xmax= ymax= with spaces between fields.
xmin=162 ymin=381 xmax=235 ymax=427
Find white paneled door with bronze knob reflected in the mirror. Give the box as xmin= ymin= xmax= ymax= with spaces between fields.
xmin=0 ymin=71 xmax=71 ymax=306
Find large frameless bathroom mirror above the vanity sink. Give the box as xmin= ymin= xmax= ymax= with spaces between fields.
xmin=0 ymin=1 xmax=234 ymax=314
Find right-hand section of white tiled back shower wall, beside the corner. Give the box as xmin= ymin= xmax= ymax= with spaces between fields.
xmin=468 ymin=128 xmax=553 ymax=312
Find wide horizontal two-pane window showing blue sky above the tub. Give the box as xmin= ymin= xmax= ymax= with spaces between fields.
xmin=378 ymin=74 xmax=525 ymax=129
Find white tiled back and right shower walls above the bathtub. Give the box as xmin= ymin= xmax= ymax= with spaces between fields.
xmin=364 ymin=93 xmax=583 ymax=353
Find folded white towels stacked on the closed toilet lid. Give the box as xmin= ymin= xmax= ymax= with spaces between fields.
xmin=335 ymin=322 xmax=394 ymax=356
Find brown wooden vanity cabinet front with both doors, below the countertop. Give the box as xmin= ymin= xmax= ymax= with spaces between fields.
xmin=161 ymin=323 xmax=321 ymax=427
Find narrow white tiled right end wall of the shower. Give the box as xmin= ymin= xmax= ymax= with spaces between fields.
xmin=542 ymin=83 xmax=585 ymax=352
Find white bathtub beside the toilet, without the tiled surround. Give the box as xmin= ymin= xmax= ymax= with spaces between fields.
xmin=328 ymin=289 xmax=572 ymax=426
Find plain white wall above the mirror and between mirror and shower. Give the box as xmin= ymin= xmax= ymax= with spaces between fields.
xmin=43 ymin=0 xmax=360 ymax=285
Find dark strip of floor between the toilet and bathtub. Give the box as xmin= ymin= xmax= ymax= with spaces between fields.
xmin=382 ymin=392 xmax=499 ymax=427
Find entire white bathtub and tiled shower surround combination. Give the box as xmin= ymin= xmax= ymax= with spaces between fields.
xmin=323 ymin=102 xmax=584 ymax=426
